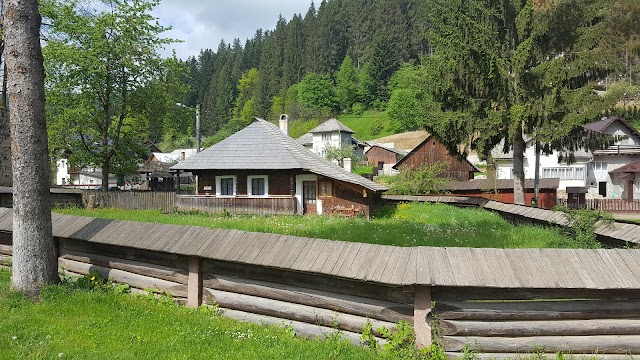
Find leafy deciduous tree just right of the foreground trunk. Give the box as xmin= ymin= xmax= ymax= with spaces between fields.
xmin=41 ymin=0 xmax=175 ymax=187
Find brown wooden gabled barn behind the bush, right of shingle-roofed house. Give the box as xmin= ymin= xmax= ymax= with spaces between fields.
xmin=393 ymin=136 xmax=480 ymax=181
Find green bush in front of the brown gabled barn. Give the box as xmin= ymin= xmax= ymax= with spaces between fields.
xmin=376 ymin=161 xmax=451 ymax=195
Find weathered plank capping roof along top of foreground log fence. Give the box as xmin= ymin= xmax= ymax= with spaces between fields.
xmin=0 ymin=207 xmax=640 ymax=289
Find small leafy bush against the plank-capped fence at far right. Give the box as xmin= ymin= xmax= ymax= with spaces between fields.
xmin=555 ymin=206 xmax=613 ymax=249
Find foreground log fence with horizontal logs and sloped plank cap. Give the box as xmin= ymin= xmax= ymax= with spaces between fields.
xmin=0 ymin=210 xmax=640 ymax=360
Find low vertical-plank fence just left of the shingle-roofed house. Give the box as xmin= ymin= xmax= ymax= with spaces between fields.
xmin=82 ymin=190 xmax=176 ymax=213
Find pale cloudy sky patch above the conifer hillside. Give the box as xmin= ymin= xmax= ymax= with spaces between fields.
xmin=153 ymin=0 xmax=318 ymax=60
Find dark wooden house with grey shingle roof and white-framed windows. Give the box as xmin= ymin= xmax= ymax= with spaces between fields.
xmin=172 ymin=119 xmax=387 ymax=216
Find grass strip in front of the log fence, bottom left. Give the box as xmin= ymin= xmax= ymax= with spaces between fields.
xmin=0 ymin=269 xmax=378 ymax=359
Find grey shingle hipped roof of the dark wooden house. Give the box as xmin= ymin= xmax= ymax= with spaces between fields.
xmin=171 ymin=119 xmax=387 ymax=191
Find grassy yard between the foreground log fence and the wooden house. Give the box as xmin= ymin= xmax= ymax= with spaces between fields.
xmin=56 ymin=203 xmax=577 ymax=248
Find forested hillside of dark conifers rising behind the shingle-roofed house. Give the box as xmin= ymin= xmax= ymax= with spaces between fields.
xmin=187 ymin=0 xmax=430 ymax=139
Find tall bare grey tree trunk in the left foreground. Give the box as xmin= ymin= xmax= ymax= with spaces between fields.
xmin=2 ymin=0 xmax=59 ymax=296
